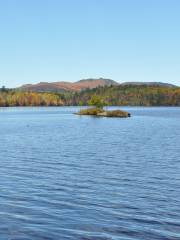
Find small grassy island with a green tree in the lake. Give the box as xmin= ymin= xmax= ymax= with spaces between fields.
xmin=75 ymin=95 xmax=131 ymax=118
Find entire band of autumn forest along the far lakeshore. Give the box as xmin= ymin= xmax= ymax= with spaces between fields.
xmin=0 ymin=85 xmax=180 ymax=107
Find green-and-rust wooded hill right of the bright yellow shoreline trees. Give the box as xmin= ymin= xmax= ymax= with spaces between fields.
xmin=68 ymin=85 xmax=180 ymax=106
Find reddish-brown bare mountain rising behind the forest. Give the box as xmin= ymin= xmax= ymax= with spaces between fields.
xmin=19 ymin=78 xmax=118 ymax=92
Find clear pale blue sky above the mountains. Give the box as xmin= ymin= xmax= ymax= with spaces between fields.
xmin=0 ymin=0 xmax=180 ymax=87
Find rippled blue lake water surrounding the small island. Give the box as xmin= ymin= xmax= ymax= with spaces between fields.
xmin=0 ymin=107 xmax=180 ymax=240
